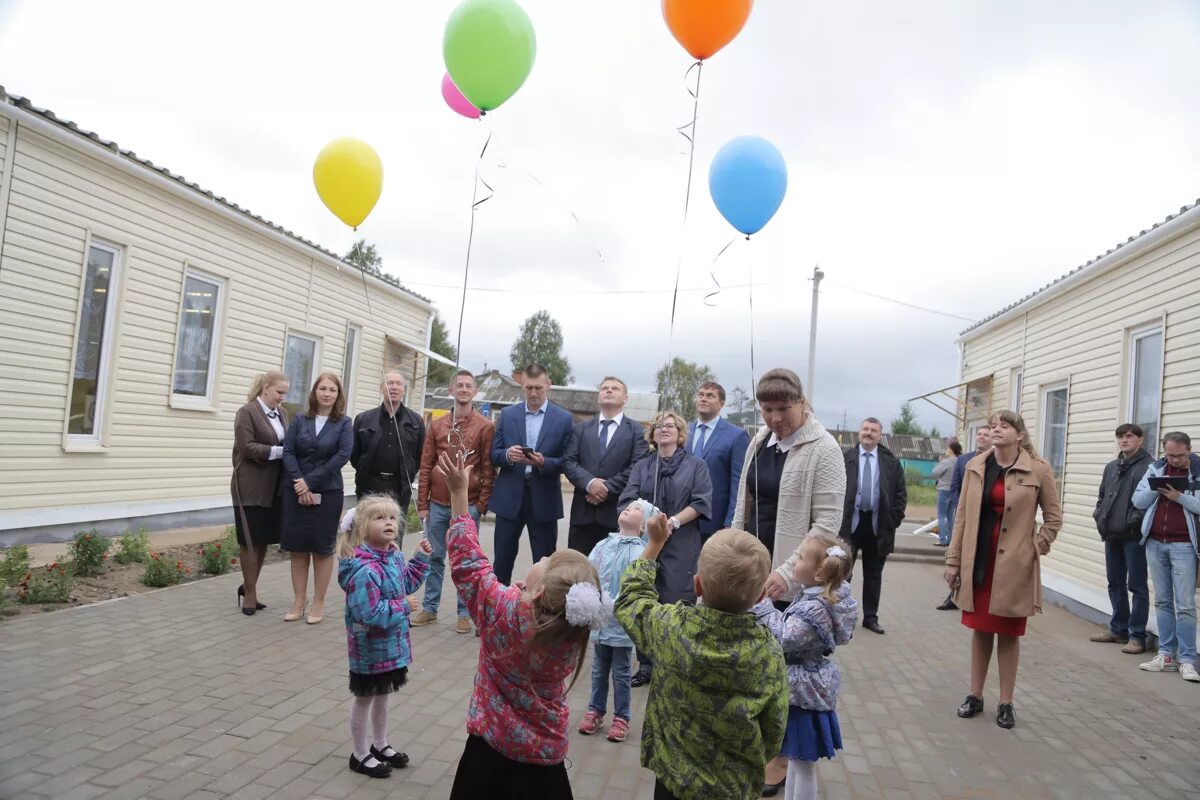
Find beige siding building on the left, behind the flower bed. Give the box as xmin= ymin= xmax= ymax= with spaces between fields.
xmin=0 ymin=89 xmax=440 ymax=542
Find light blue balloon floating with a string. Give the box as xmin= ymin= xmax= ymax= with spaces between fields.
xmin=708 ymin=136 xmax=787 ymax=236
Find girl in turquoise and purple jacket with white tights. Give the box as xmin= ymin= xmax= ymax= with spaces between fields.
xmin=337 ymin=494 xmax=432 ymax=777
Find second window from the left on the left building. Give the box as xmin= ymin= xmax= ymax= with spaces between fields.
xmin=172 ymin=270 xmax=224 ymax=407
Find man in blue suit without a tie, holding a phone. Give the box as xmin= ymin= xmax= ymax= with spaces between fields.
xmin=491 ymin=363 xmax=572 ymax=584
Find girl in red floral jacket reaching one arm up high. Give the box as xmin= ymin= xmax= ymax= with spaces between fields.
xmin=438 ymin=453 xmax=612 ymax=800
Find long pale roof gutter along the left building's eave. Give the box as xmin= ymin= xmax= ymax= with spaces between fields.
xmin=0 ymin=95 xmax=433 ymax=314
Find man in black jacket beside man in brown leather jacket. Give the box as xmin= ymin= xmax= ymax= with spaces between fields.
xmin=350 ymin=372 xmax=425 ymax=510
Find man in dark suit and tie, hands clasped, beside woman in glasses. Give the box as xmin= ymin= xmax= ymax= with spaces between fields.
xmin=563 ymin=377 xmax=650 ymax=555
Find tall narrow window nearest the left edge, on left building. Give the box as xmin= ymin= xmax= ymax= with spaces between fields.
xmin=67 ymin=240 xmax=120 ymax=441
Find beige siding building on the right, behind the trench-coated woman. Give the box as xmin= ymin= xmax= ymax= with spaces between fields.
xmin=959 ymin=196 xmax=1200 ymax=624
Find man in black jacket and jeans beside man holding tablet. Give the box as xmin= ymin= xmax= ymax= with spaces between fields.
xmin=1092 ymin=423 xmax=1153 ymax=655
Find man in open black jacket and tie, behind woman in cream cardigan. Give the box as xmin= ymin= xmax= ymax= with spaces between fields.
xmin=839 ymin=416 xmax=908 ymax=633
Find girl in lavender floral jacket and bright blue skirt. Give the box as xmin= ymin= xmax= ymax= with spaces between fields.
xmin=750 ymin=535 xmax=858 ymax=800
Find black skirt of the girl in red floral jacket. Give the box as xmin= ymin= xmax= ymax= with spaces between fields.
xmin=450 ymin=734 xmax=572 ymax=800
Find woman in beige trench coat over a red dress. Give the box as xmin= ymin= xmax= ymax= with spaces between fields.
xmin=946 ymin=411 xmax=1062 ymax=728
